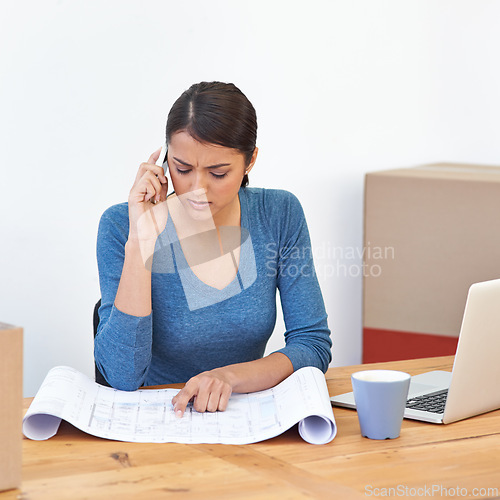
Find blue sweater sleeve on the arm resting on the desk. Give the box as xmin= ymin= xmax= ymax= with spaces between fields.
xmin=269 ymin=191 xmax=332 ymax=372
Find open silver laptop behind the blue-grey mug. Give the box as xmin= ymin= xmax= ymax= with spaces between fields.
xmin=330 ymin=279 xmax=500 ymax=424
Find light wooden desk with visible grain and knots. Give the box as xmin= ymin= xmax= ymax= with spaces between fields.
xmin=0 ymin=356 xmax=500 ymax=500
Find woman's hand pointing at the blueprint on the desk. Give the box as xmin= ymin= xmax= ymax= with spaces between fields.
xmin=172 ymin=368 xmax=233 ymax=418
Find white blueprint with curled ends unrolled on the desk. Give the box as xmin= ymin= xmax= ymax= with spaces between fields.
xmin=23 ymin=366 xmax=337 ymax=444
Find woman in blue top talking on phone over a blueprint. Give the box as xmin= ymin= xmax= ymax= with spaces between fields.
xmin=95 ymin=82 xmax=331 ymax=417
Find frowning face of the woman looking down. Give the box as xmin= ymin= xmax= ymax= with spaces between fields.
xmin=168 ymin=132 xmax=257 ymax=224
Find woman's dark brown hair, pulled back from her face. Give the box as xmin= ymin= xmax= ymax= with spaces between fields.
xmin=166 ymin=82 xmax=257 ymax=187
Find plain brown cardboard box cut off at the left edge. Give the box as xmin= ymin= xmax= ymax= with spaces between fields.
xmin=0 ymin=323 xmax=23 ymax=491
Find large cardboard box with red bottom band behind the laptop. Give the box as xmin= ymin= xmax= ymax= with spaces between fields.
xmin=363 ymin=164 xmax=500 ymax=362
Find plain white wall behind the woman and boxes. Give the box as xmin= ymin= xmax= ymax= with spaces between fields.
xmin=0 ymin=0 xmax=500 ymax=396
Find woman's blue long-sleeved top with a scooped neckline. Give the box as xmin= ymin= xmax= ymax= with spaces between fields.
xmin=94 ymin=188 xmax=332 ymax=390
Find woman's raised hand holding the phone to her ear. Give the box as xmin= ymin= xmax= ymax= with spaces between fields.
xmin=128 ymin=148 xmax=168 ymax=247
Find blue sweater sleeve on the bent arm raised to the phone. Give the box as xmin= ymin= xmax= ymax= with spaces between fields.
xmin=94 ymin=203 xmax=152 ymax=391
